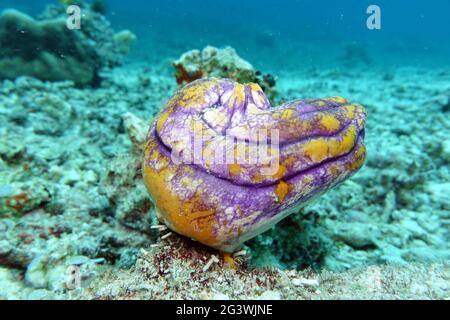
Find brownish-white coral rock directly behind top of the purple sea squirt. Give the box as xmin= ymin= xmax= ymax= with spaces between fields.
xmin=173 ymin=46 xmax=276 ymax=101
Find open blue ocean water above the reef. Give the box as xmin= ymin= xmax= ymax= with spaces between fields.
xmin=0 ymin=0 xmax=450 ymax=71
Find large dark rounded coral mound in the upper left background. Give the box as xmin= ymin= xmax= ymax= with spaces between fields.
xmin=0 ymin=3 xmax=135 ymax=86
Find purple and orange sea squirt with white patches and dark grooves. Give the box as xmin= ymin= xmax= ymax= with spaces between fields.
xmin=143 ymin=78 xmax=366 ymax=253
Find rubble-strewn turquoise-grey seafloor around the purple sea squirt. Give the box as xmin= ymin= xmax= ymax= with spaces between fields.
xmin=0 ymin=58 xmax=450 ymax=299
